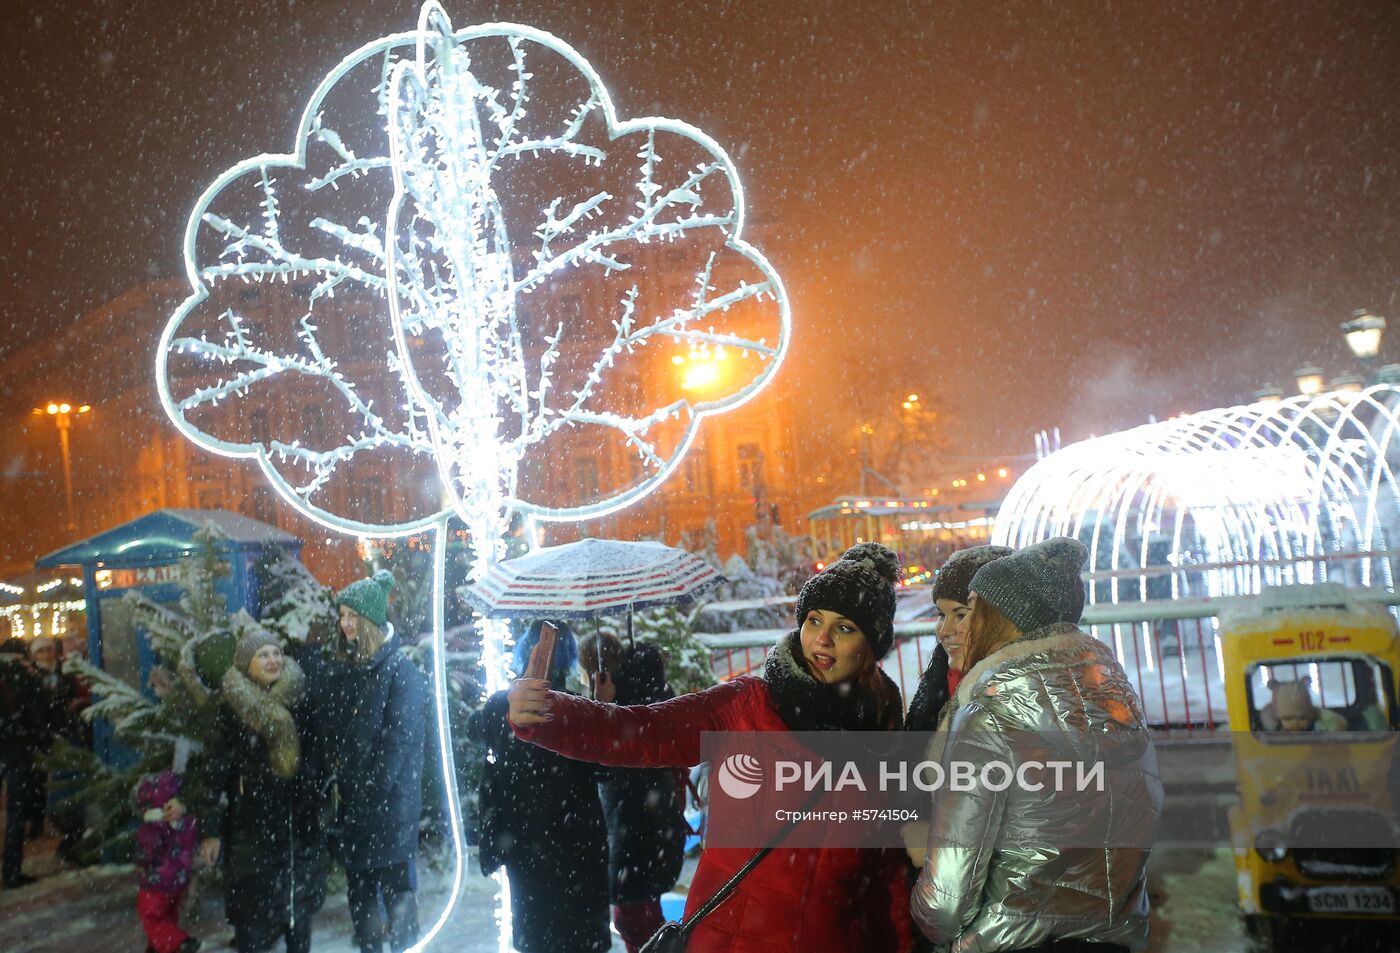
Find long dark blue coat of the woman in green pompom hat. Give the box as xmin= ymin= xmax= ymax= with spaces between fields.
xmin=321 ymin=635 xmax=428 ymax=870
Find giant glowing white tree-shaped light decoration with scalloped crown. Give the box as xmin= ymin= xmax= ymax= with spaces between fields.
xmin=157 ymin=0 xmax=790 ymax=946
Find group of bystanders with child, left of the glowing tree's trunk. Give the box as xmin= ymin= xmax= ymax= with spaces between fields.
xmin=0 ymin=571 xmax=428 ymax=953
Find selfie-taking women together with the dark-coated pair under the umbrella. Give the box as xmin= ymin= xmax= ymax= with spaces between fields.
xmin=509 ymin=537 xmax=1162 ymax=953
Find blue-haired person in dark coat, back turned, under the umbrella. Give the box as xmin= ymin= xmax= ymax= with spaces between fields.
xmin=472 ymin=621 xmax=612 ymax=953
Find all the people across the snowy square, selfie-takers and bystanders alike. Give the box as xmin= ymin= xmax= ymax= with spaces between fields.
xmin=0 ymin=539 xmax=1162 ymax=953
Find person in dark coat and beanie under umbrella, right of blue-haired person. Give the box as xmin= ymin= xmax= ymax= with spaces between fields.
xmin=578 ymin=628 xmax=689 ymax=953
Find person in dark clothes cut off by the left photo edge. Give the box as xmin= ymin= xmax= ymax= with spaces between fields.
xmin=0 ymin=638 xmax=50 ymax=887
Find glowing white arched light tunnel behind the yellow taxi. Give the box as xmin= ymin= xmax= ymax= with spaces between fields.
xmin=994 ymin=385 xmax=1400 ymax=605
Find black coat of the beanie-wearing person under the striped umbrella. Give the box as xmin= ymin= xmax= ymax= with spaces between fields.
xmin=598 ymin=645 xmax=689 ymax=904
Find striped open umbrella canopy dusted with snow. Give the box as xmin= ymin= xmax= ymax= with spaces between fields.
xmin=458 ymin=539 xmax=724 ymax=619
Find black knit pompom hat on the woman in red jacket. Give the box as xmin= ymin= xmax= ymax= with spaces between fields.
xmin=797 ymin=543 xmax=900 ymax=661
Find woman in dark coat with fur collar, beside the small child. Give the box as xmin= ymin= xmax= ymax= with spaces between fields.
xmin=200 ymin=628 xmax=326 ymax=953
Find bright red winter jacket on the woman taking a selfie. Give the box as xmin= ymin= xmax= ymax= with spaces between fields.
xmin=512 ymin=676 xmax=913 ymax=953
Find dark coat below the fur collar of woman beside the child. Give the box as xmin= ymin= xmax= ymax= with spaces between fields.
xmin=200 ymin=671 xmax=326 ymax=950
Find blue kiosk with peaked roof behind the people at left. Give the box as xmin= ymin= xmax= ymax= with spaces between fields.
xmin=35 ymin=509 xmax=301 ymax=760
